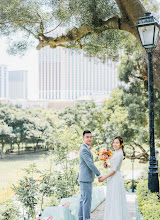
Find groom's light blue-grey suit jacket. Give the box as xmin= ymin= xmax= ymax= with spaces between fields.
xmin=78 ymin=144 xmax=101 ymax=182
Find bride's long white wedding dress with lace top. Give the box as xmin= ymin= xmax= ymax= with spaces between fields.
xmin=104 ymin=149 xmax=129 ymax=220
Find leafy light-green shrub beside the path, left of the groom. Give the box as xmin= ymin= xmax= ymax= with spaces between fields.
xmin=13 ymin=151 xmax=79 ymax=218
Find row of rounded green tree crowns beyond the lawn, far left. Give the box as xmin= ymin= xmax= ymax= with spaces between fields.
xmin=0 ymin=105 xmax=55 ymax=154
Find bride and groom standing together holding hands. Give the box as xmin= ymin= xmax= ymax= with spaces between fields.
xmin=78 ymin=131 xmax=129 ymax=220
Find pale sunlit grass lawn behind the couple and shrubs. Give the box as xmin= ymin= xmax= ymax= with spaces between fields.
xmin=0 ymin=151 xmax=151 ymax=194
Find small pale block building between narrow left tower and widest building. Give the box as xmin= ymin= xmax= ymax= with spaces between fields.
xmin=8 ymin=70 xmax=28 ymax=99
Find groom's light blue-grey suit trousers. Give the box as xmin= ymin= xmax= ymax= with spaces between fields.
xmin=78 ymin=182 xmax=92 ymax=220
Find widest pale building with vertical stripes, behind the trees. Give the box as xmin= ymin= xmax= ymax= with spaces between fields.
xmin=39 ymin=47 xmax=121 ymax=100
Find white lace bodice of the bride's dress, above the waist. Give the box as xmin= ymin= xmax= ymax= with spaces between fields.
xmin=110 ymin=149 xmax=123 ymax=172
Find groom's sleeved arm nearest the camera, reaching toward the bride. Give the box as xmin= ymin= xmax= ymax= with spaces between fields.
xmin=81 ymin=149 xmax=101 ymax=178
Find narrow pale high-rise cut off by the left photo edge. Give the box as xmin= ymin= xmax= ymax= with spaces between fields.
xmin=0 ymin=65 xmax=8 ymax=98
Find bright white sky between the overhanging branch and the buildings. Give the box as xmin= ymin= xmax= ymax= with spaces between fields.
xmin=0 ymin=0 xmax=160 ymax=99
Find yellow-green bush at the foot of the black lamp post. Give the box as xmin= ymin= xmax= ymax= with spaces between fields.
xmin=136 ymin=181 xmax=160 ymax=220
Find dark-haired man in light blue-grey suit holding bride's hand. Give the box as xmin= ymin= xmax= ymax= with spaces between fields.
xmin=78 ymin=131 xmax=101 ymax=220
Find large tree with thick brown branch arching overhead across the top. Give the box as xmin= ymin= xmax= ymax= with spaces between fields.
xmin=0 ymin=0 xmax=160 ymax=90
